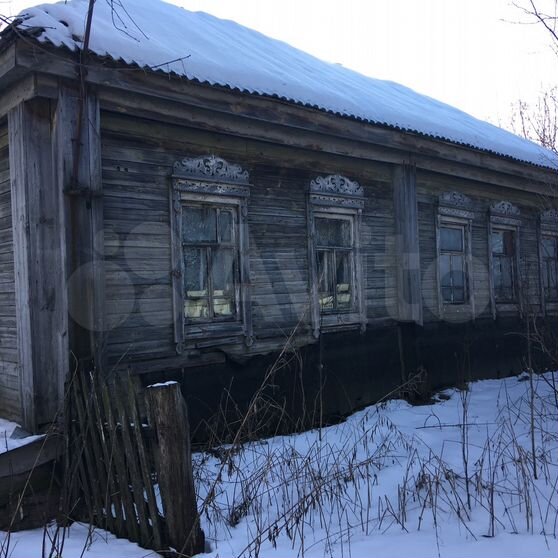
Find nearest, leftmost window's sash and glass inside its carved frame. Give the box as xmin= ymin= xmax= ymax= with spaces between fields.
xmin=182 ymin=205 xmax=239 ymax=321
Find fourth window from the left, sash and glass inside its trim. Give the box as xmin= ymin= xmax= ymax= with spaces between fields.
xmin=491 ymin=229 xmax=516 ymax=302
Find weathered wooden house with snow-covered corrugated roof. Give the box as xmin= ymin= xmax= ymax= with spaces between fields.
xmin=0 ymin=0 xmax=558 ymax=430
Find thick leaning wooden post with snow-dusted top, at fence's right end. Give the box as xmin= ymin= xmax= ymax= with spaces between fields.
xmin=147 ymin=382 xmax=205 ymax=556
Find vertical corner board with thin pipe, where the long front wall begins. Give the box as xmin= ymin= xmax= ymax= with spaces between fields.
xmin=54 ymin=87 xmax=105 ymax=374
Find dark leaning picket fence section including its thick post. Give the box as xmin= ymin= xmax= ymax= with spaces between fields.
xmin=63 ymin=371 xmax=204 ymax=556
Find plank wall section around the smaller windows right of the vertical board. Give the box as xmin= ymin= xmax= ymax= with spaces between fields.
xmin=418 ymin=175 xmax=540 ymax=322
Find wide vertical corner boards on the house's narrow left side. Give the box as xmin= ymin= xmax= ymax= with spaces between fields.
xmin=8 ymin=98 xmax=68 ymax=431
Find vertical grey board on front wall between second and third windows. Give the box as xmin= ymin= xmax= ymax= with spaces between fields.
xmin=393 ymin=165 xmax=422 ymax=325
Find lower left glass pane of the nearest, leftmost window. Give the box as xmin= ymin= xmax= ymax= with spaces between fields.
xmin=184 ymin=248 xmax=209 ymax=318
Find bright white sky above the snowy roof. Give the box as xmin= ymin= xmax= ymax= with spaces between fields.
xmin=4 ymin=0 xmax=558 ymax=127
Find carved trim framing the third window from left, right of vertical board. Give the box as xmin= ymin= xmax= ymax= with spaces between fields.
xmin=436 ymin=195 xmax=475 ymax=320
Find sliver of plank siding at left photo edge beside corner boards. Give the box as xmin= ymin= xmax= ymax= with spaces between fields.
xmin=0 ymin=123 xmax=22 ymax=421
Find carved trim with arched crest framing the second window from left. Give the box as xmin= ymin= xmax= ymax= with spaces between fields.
xmin=307 ymin=174 xmax=367 ymax=338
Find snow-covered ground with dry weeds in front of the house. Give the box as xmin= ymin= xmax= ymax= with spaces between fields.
xmin=0 ymin=373 xmax=558 ymax=558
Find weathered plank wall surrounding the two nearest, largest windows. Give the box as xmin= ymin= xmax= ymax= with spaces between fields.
xmin=101 ymin=113 xmax=396 ymax=363
